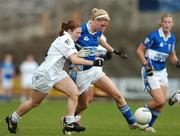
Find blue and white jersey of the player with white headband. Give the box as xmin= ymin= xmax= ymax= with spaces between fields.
xmin=73 ymin=21 xmax=102 ymax=71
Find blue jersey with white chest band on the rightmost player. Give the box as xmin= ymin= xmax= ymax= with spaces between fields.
xmin=143 ymin=28 xmax=176 ymax=71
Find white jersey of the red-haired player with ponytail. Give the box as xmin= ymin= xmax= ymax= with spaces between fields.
xmin=36 ymin=32 xmax=77 ymax=77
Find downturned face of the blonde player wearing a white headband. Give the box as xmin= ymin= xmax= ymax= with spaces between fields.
xmin=94 ymin=20 xmax=109 ymax=31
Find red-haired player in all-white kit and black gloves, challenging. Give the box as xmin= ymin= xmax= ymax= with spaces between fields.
xmin=6 ymin=20 xmax=103 ymax=133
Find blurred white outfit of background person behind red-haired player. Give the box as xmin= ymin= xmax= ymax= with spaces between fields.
xmin=20 ymin=61 xmax=38 ymax=88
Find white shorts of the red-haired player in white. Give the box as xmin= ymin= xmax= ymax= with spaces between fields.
xmin=32 ymin=70 xmax=68 ymax=93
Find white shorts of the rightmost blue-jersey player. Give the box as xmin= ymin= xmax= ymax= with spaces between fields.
xmin=141 ymin=68 xmax=168 ymax=91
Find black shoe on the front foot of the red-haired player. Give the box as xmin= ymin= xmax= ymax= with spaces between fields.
xmin=61 ymin=117 xmax=86 ymax=135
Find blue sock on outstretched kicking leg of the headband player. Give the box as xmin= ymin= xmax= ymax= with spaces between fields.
xmin=118 ymin=104 xmax=136 ymax=124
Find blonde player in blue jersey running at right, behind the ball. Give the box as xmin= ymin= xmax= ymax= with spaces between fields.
xmin=136 ymin=14 xmax=180 ymax=132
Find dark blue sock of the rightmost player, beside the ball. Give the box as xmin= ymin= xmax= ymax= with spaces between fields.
xmin=144 ymin=104 xmax=160 ymax=127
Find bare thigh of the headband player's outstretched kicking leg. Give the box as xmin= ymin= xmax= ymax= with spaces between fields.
xmin=95 ymin=75 xmax=122 ymax=97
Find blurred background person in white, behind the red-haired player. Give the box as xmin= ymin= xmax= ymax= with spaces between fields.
xmin=20 ymin=54 xmax=38 ymax=102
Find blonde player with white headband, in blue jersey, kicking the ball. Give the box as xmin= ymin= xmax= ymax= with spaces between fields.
xmin=70 ymin=8 xmax=148 ymax=131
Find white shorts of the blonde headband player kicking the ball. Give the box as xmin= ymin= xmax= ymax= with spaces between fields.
xmin=70 ymin=67 xmax=105 ymax=94
